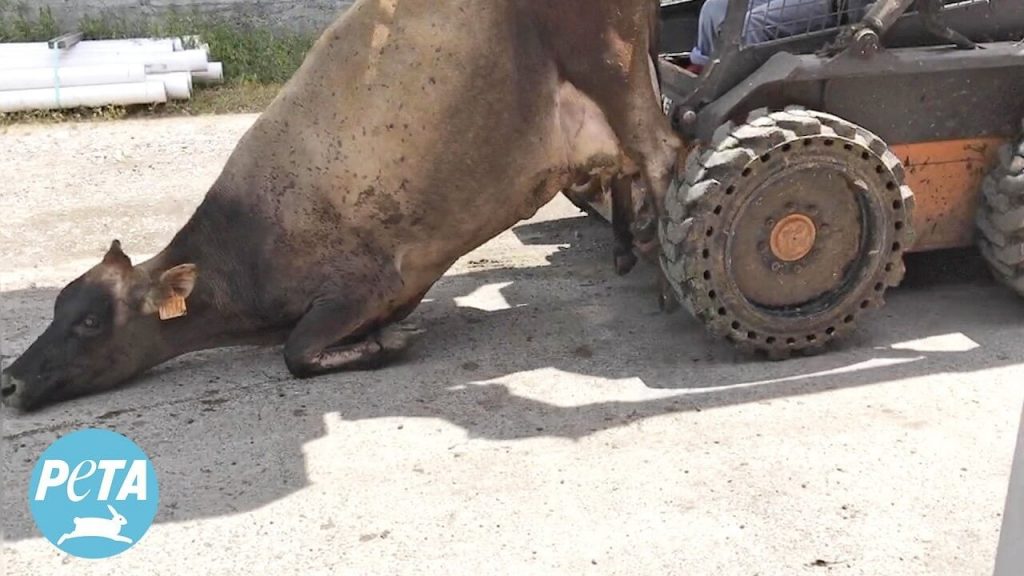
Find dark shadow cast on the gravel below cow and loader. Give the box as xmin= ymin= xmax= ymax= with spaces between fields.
xmin=2 ymin=211 xmax=1024 ymax=539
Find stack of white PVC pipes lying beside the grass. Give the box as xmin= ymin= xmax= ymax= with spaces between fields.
xmin=0 ymin=37 xmax=224 ymax=112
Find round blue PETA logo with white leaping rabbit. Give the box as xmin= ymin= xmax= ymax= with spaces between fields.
xmin=29 ymin=428 xmax=160 ymax=559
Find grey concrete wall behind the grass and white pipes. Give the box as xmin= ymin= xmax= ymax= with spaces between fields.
xmin=7 ymin=0 xmax=353 ymax=31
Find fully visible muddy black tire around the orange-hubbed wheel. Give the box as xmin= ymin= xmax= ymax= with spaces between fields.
xmin=658 ymin=107 xmax=913 ymax=360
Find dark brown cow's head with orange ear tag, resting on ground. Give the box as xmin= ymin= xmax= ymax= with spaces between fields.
xmin=0 ymin=241 xmax=196 ymax=410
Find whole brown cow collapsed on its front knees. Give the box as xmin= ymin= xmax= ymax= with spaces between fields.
xmin=2 ymin=0 xmax=680 ymax=410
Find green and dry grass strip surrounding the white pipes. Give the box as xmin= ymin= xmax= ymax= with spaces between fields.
xmin=0 ymin=0 xmax=318 ymax=125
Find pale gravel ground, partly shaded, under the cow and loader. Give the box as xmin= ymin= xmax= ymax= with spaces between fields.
xmin=0 ymin=116 xmax=1024 ymax=576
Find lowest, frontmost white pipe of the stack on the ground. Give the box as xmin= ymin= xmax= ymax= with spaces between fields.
xmin=0 ymin=80 xmax=167 ymax=112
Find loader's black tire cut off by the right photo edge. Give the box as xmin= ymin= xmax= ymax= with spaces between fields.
xmin=977 ymin=138 xmax=1024 ymax=296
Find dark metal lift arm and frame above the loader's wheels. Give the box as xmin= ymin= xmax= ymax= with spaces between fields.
xmin=659 ymin=0 xmax=1024 ymax=145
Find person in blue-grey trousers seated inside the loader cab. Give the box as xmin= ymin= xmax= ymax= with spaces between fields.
xmin=687 ymin=0 xmax=872 ymax=74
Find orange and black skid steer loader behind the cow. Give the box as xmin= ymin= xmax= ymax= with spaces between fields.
xmin=573 ymin=0 xmax=1024 ymax=358
